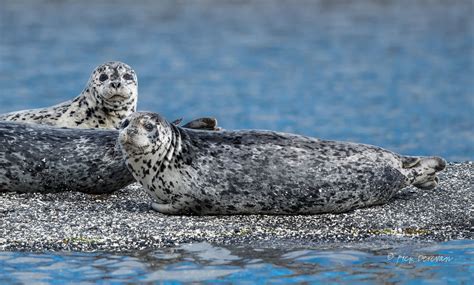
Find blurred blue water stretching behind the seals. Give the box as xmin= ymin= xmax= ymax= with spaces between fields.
xmin=0 ymin=0 xmax=474 ymax=161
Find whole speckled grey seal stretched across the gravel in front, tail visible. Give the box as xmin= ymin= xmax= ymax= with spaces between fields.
xmin=118 ymin=112 xmax=446 ymax=215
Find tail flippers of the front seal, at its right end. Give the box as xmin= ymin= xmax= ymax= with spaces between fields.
xmin=402 ymin=156 xmax=446 ymax=190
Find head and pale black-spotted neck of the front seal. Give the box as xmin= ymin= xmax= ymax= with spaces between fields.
xmin=118 ymin=112 xmax=188 ymax=206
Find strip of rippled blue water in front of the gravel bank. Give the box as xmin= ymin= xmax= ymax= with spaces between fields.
xmin=0 ymin=241 xmax=474 ymax=284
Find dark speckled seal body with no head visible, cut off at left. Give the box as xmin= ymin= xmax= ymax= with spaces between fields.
xmin=0 ymin=122 xmax=134 ymax=194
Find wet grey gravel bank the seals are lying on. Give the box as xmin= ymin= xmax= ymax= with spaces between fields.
xmin=0 ymin=162 xmax=474 ymax=251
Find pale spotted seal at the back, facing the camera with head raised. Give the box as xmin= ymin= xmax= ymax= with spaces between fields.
xmin=0 ymin=61 xmax=138 ymax=129
